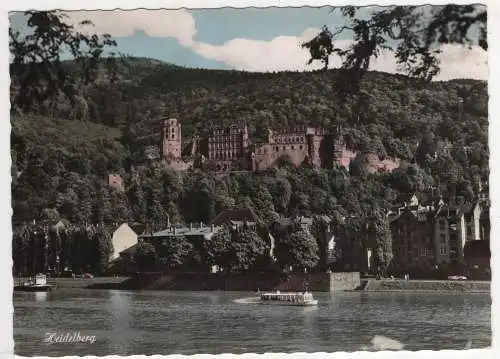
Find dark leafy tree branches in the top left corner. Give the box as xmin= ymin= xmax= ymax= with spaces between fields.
xmin=9 ymin=11 xmax=116 ymax=111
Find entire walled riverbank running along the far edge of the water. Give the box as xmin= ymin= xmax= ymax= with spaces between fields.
xmin=14 ymin=273 xmax=491 ymax=293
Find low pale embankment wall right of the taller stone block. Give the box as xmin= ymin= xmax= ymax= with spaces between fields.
xmin=359 ymin=279 xmax=491 ymax=293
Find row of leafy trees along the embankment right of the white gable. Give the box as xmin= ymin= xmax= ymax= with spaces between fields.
xmin=133 ymin=216 xmax=392 ymax=274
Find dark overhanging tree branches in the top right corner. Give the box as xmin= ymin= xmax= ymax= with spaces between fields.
xmin=302 ymin=5 xmax=488 ymax=97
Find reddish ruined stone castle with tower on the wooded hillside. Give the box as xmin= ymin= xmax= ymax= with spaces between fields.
xmin=154 ymin=118 xmax=400 ymax=173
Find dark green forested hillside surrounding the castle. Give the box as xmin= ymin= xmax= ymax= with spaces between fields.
xmin=11 ymin=58 xmax=488 ymax=227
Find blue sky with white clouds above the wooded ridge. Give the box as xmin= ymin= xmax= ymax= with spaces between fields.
xmin=10 ymin=7 xmax=488 ymax=80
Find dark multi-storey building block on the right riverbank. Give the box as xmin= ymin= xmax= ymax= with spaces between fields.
xmin=389 ymin=194 xmax=490 ymax=274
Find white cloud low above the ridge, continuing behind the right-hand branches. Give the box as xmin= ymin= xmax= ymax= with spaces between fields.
xmin=192 ymin=29 xmax=488 ymax=80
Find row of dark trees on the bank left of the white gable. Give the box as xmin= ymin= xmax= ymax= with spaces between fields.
xmin=12 ymin=223 xmax=113 ymax=276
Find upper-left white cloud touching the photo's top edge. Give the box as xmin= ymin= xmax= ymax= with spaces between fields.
xmin=66 ymin=9 xmax=196 ymax=46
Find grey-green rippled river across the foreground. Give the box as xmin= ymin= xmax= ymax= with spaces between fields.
xmin=14 ymin=289 xmax=492 ymax=356
